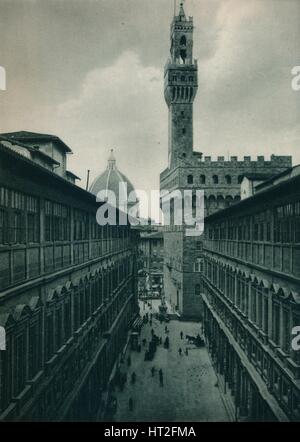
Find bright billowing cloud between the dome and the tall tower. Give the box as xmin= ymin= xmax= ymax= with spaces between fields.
xmin=54 ymin=51 xmax=167 ymax=218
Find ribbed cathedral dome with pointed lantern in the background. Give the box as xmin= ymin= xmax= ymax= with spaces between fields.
xmin=89 ymin=149 xmax=135 ymax=208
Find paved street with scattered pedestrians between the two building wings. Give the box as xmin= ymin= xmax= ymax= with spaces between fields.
xmin=114 ymin=301 xmax=229 ymax=422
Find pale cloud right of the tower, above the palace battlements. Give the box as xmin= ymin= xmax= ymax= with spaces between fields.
xmin=195 ymin=0 xmax=300 ymax=162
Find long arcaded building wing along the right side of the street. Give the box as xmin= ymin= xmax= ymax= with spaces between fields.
xmin=201 ymin=168 xmax=300 ymax=421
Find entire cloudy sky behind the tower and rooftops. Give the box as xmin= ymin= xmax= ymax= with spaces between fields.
xmin=0 ymin=0 xmax=300 ymax=218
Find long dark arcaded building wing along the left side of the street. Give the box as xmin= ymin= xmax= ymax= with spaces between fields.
xmin=0 ymin=139 xmax=138 ymax=421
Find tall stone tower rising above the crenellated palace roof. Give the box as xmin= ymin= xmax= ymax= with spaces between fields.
xmin=165 ymin=2 xmax=198 ymax=169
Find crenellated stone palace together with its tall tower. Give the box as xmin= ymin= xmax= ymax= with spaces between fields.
xmin=160 ymin=5 xmax=292 ymax=318
